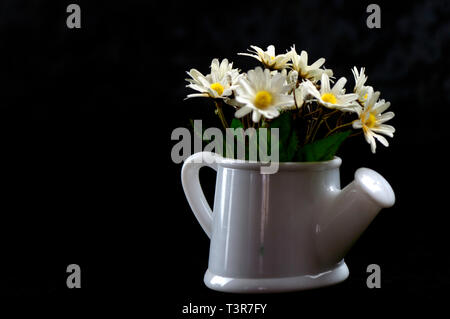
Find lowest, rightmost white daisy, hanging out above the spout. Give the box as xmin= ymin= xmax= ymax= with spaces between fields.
xmin=353 ymin=92 xmax=395 ymax=153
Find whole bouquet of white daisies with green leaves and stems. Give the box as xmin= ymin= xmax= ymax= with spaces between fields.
xmin=187 ymin=45 xmax=395 ymax=162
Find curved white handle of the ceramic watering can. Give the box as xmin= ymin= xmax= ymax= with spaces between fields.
xmin=181 ymin=152 xmax=219 ymax=238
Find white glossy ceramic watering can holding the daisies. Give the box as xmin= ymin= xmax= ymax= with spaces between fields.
xmin=181 ymin=152 xmax=395 ymax=293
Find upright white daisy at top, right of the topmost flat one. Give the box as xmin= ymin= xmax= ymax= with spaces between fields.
xmin=291 ymin=46 xmax=333 ymax=83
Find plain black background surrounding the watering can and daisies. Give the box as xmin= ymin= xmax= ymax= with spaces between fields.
xmin=0 ymin=0 xmax=450 ymax=318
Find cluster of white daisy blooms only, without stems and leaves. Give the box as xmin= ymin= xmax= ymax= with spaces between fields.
xmin=187 ymin=45 xmax=395 ymax=153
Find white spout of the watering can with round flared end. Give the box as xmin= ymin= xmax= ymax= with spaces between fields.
xmin=316 ymin=168 xmax=395 ymax=264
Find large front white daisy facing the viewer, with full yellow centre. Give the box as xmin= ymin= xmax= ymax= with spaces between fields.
xmin=235 ymin=67 xmax=294 ymax=122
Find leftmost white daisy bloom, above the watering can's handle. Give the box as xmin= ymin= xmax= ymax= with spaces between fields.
xmin=186 ymin=59 xmax=240 ymax=99
